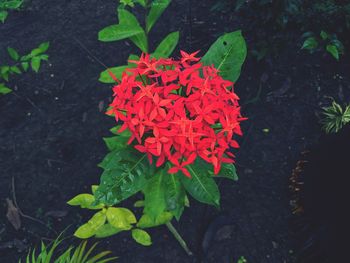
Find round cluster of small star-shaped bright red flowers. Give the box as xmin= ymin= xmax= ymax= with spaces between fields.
xmin=107 ymin=51 xmax=245 ymax=177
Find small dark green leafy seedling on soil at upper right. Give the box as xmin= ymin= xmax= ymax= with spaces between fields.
xmin=301 ymin=31 xmax=344 ymax=60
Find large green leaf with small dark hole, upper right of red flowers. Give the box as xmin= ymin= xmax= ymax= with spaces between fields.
xmin=201 ymin=31 xmax=247 ymax=82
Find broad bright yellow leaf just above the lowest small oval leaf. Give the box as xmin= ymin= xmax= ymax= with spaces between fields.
xmin=107 ymin=207 xmax=137 ymax=230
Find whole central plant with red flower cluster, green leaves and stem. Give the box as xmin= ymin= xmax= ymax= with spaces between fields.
xmin=68 ymin=0 xmax=247 ymax=250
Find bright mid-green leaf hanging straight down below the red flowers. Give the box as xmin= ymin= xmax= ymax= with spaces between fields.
xmin=143 ymin=169 xmax=169 ymax=220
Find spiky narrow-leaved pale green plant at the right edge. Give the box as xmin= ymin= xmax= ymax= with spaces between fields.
xmin=321 ymin=101 xmax=350 ymax=133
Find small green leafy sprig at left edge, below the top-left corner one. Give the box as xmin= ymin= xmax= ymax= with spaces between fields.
xmin=0 ymin=42 xmax=50 ymax=95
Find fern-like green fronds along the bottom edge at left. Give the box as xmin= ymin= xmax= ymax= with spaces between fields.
xmin=19 ymin=237 xmax=117 ymax=263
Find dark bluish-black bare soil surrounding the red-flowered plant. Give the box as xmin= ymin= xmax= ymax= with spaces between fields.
xmin=0 ymin=0 xmax=350 ymax=263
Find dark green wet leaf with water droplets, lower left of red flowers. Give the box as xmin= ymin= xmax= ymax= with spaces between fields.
xmin=95 ymin=147 xmax=153 ymax=205
